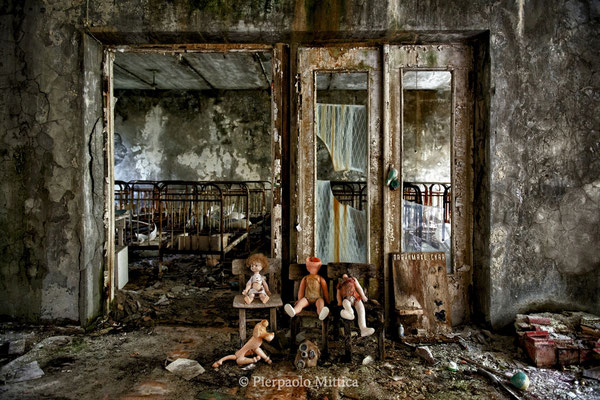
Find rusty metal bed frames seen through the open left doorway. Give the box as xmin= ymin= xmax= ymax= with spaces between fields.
xmin=114 ymin=180 xmax=272 ymax=259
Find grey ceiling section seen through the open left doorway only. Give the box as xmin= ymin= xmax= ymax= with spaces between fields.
xmin=113 ymin=52 xmax=271 ymax=90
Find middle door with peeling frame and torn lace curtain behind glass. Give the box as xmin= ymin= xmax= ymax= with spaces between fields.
xmin=296 ymin=48 xmax=382 ymax=264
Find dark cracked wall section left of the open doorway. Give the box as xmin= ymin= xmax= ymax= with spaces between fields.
xmin=0 ymin=1 xmax=85 ymax=321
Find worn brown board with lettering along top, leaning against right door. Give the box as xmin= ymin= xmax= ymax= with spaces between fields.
xmin=393 ymin=252 xmax=452 ymax=332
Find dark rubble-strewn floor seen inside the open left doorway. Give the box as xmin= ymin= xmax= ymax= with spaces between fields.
xmin=107 ymin=255 xmax=239 ymax=328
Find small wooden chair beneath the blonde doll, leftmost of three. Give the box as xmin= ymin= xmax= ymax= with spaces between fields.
xmin=231 ymin=258 xmax=283 ymax=346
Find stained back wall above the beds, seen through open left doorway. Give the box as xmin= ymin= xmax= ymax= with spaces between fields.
xmin=115 ymin=90 xmax=271 ymax=181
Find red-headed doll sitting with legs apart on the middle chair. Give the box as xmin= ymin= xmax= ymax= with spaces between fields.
xmin=284 ymin=257 xmax=329 ymax=321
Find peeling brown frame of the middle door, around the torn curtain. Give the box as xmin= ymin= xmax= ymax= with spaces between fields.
xmin=292 ymin=46 xmax=383 ymax=290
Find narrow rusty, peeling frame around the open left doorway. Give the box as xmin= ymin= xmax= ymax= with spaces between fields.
xmin=103 ymin=43 xmax=287 ymax=310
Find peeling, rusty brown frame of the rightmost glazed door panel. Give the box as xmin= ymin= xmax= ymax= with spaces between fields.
xmin=384 ymin=44 xmax=474 ymax=324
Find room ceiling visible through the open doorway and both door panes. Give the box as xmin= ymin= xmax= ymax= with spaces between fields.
xmin=113 ymin=52 xmax=451 ymax=90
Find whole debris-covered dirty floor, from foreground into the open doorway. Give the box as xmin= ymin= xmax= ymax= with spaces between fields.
xmin=0 ymin=258 xmax=600 ymax=400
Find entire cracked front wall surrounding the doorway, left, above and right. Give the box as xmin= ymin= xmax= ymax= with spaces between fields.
xmin=0 ymin=0 xmax=600 ymax=326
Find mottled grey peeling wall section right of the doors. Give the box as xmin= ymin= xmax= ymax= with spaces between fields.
xmin=489 ymin=1 xmax=600 ymax=326
